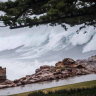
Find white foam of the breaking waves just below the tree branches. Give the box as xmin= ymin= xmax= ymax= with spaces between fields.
xmin=0 ymin=25 xmax=96 ymax=57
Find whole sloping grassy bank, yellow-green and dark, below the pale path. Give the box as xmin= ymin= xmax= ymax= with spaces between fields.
xmin=12 ymin=80 xmax=96 ymax=96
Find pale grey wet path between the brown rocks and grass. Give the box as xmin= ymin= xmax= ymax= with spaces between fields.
xmin=0 ymin=74 xmax=96 ymax=96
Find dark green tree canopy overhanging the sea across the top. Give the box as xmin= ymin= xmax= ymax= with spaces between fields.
xmin=0 ymin=0 xmax=96 ymax=29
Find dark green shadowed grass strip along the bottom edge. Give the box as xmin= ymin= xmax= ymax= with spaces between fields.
xmin=28 ymin=87 xmax=96 ymax=96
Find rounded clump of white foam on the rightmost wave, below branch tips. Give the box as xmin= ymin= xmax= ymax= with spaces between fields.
xmin=71 ymin=27 xmax=96 ymax=46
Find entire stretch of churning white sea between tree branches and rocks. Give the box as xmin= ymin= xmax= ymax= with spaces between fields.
xmin=0 ymin=25 xmax=96 ymax=80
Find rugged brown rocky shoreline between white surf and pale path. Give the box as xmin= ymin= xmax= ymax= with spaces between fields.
xmin=0 ymin=55 xmax=96 ymax=89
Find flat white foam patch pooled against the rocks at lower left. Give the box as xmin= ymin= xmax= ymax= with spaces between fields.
xmin=0 ymin=60 xmax=56 ymax=80
